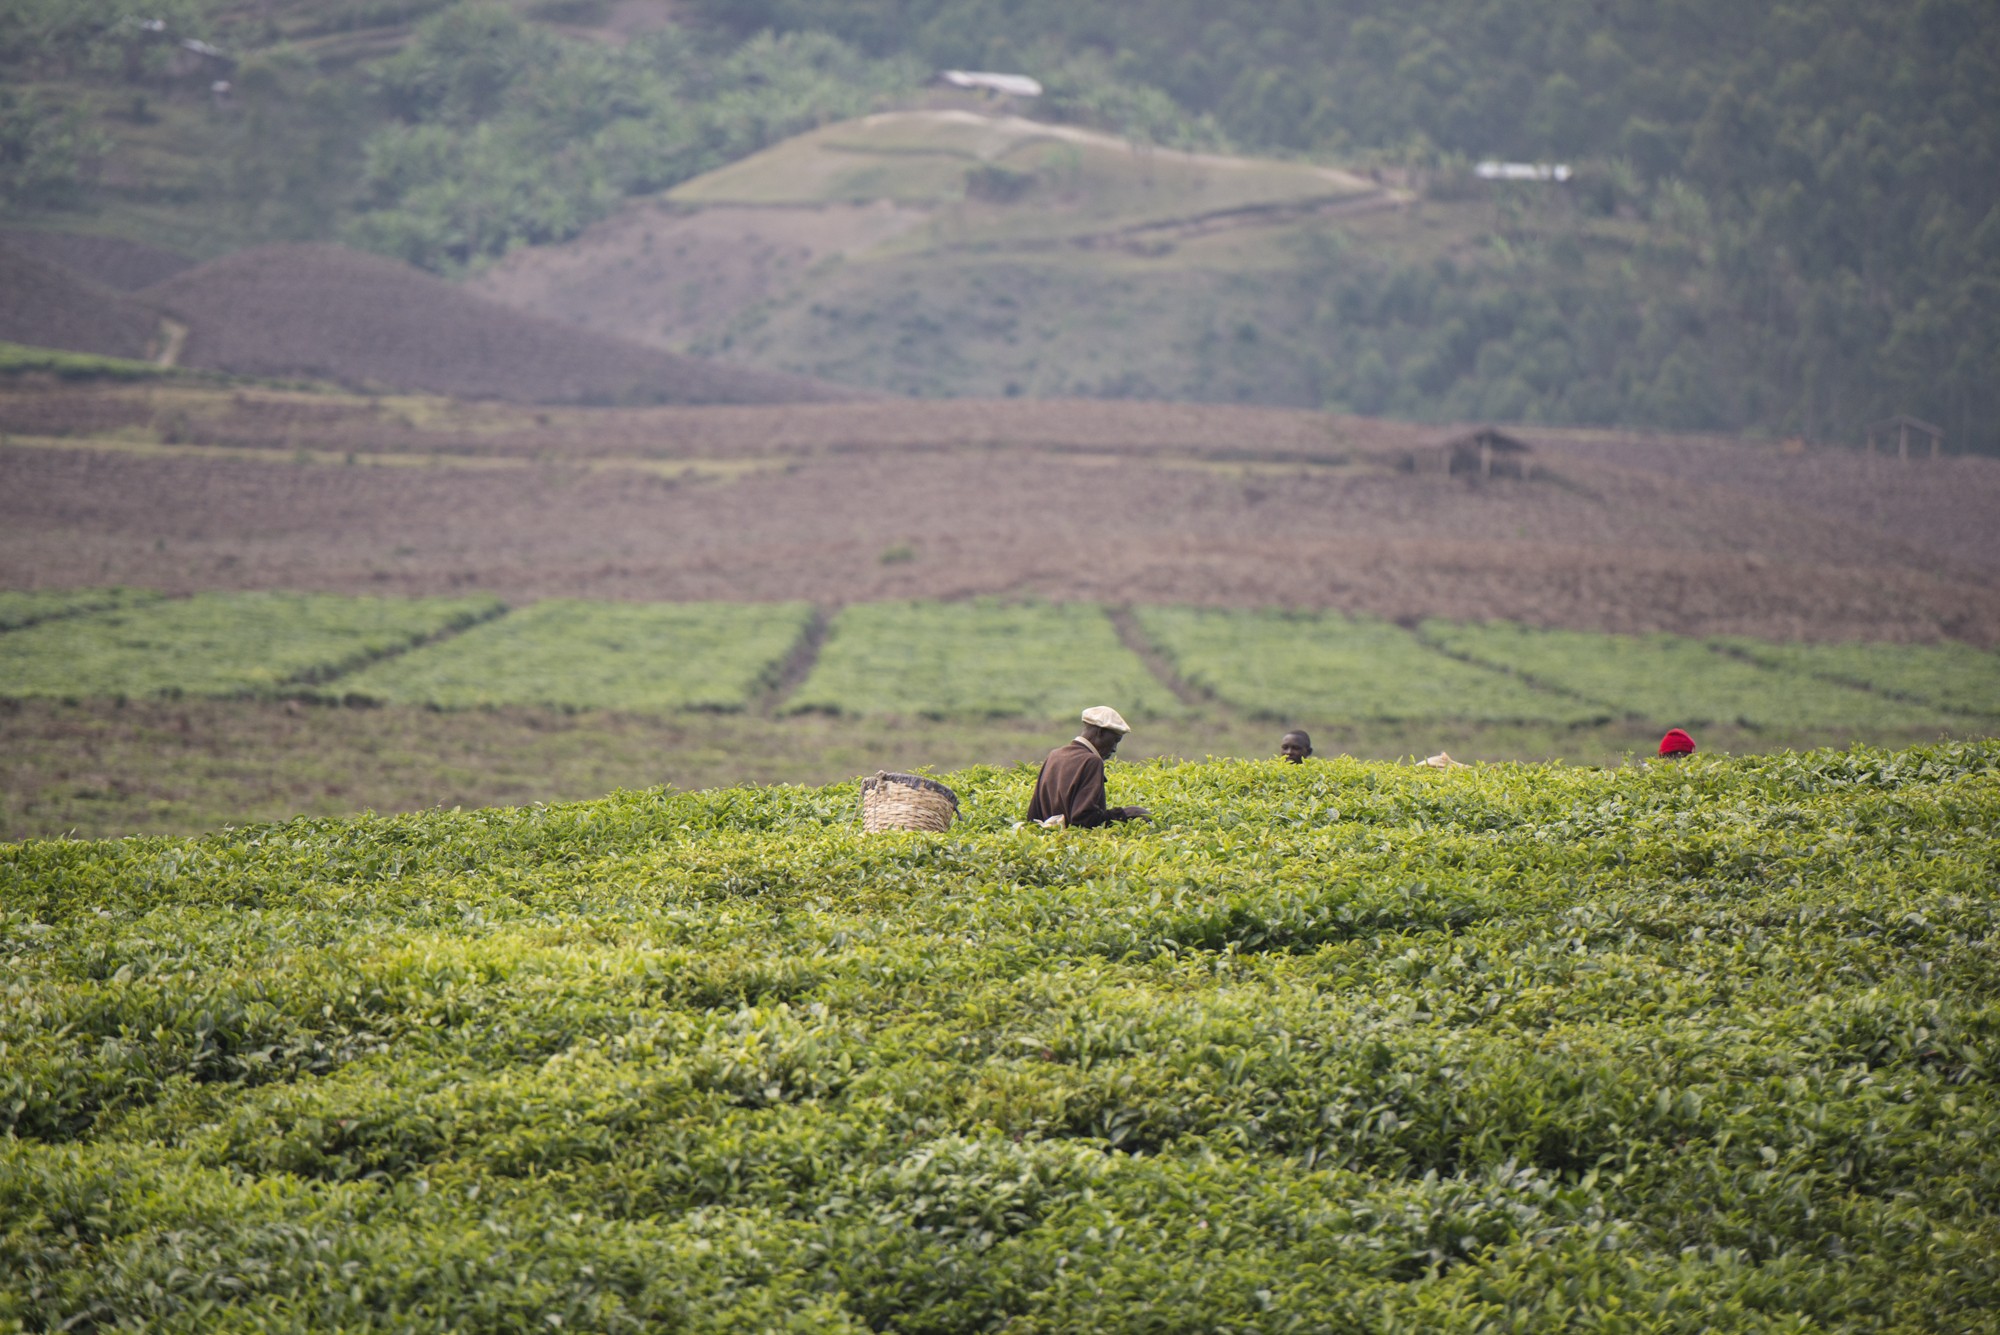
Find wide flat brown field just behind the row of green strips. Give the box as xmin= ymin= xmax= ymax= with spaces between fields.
xmin=0 ymin=386 xmax=2000 ymax=646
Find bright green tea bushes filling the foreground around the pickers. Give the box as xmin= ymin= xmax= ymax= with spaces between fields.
xmin=0 ymin=741 xmax=2000 ymax=1333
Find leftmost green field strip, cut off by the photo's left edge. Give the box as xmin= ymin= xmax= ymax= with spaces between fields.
xmin=0 ymin=594 xmax=500 ymax=699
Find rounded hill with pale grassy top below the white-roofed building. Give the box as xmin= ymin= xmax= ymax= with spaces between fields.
xmin=470 ymin=108 xmax=1408 ymax=408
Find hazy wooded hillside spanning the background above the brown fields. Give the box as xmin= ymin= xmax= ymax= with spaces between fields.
xmin=0 ymin=0 xmax=2000 ymax=450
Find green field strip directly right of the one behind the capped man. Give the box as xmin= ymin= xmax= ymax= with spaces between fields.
xmin=1132 ymin=608 xmax=1612 ymax=725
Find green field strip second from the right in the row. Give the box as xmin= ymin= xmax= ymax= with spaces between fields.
xmin=1420 ymin=622 xmax=1954 ymax=729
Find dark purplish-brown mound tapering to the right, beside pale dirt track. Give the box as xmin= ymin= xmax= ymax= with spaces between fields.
xmin=140 ymin=244 xmax=864 ymax=404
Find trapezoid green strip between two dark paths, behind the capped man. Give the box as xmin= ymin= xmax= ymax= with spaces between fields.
xmin=786 ymin=602 xmax=1186 ymax=727
